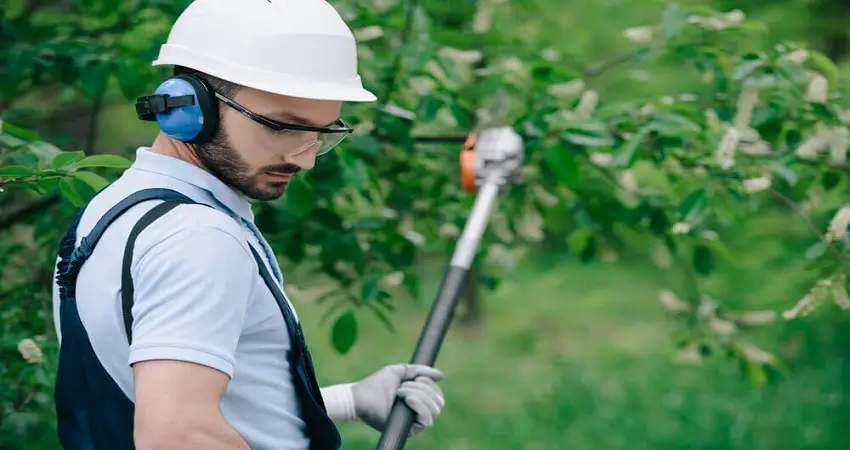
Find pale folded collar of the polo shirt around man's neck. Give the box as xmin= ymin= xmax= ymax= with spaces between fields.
xmin=126 ymin=147 xmax=254 ymax=223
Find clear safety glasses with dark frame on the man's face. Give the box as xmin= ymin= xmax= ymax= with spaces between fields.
xmin=215 ymin=92 xmax=354 ymax=156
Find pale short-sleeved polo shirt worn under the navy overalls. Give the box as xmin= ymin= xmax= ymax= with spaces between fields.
xmin=53 ymin=148 xmax=308 ymax=450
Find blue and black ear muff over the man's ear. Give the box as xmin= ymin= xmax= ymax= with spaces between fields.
xmin=136 ymin=75 xmax=218 ymax=143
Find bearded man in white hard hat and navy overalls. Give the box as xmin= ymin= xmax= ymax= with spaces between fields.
xmin=54 ymin=0 xmax=444 ymax=450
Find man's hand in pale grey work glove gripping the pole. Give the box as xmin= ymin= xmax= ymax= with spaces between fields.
xmin=351 ymin=364 xmax=445 ymax=436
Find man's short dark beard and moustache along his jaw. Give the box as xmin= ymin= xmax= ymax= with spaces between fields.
xmin=195 ymin=127 xmax=301 ymax=201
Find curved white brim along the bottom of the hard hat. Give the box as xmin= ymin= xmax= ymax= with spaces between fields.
xmin=153 ymin=44 xmax=377 ymax=102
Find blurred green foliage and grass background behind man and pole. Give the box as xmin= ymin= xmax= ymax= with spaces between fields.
xmin=0 ymin=0 xmax=850 ymax=450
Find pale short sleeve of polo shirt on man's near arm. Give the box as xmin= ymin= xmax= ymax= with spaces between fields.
xmin=124 ymin=225 xmax=256 ymax=378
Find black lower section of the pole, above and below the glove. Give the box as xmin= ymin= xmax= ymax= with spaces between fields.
xmin=378 ymin=266 xmax=468 ymax=450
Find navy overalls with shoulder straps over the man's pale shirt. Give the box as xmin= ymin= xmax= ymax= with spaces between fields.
xmin=54 ymin=189 xmax=341 ymax=450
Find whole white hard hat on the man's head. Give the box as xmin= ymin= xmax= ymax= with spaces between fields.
xmin=153 ymin=0 xmax=376 ymax=102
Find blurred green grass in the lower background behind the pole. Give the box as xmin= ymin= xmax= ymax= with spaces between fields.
xmin=297 ymin=229 xmax=850 ymax=450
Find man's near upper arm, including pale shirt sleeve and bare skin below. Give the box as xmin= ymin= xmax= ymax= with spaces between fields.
xmin=128 ymin=213 xmax=256 ymax=450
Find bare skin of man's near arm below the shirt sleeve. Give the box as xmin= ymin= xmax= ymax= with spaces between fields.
xmin=133 ymin=360 xmax=245 ymax=450
